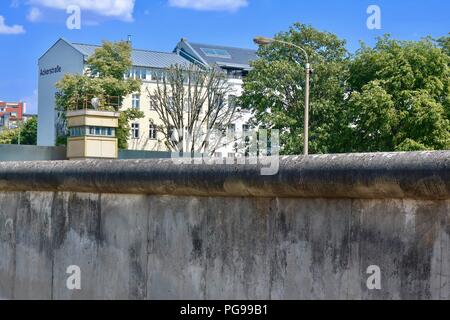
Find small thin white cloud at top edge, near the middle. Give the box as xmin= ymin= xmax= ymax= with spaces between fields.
xmin=169 ymin=0 xmax=248 ymax=11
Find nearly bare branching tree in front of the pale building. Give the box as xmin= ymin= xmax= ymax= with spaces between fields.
xmin=147 ymin=65 xmax=238 ymax=155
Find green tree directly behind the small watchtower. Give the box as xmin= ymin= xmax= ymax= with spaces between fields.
xmin=56 ymin=41 xmax=144 ymax=149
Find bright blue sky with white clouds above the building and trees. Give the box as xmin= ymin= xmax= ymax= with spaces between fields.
xmin=0 ymin=0 xmax=450 ymax=113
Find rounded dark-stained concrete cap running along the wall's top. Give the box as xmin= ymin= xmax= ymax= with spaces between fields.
xmin=0 ymin=151 xmax=450 ymax=200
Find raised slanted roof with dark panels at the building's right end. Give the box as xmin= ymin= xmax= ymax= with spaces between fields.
xmin=178 ymin=40 xmax=258 ymax=69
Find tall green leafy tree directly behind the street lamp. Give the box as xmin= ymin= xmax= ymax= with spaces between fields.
xmin=241 ymin=23 xmax=349 ymax=154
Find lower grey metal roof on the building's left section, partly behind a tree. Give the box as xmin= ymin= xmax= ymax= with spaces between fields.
xmin=72 ymin=43 xmax=189 ymax=69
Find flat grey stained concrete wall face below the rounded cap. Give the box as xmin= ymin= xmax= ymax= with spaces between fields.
xmin=0 ymin=192 xmax=450 ymax=299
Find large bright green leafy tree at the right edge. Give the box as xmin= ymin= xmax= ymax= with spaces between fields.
xmin=346 ymin=36 xmax=450 ymax=152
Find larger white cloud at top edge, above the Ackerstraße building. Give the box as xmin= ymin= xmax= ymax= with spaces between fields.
xmin=29 ymin=0 xmax=135 ymax=21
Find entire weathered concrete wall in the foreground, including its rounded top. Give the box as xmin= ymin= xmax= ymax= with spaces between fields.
xmin=0 ymin=152 xmax=450 ymax=299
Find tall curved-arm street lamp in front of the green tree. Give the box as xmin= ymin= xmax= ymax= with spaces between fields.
xmin=253 ymin=37 xmax=312 ymax=156
